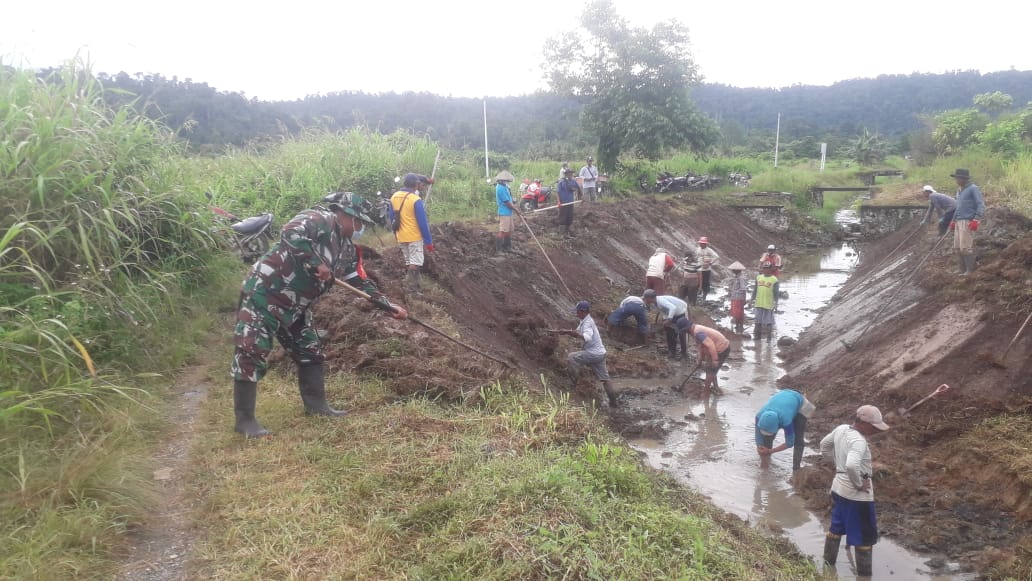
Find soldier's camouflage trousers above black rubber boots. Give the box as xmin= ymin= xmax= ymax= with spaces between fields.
xmin=230 ymin=276 xmax=326 ymax=382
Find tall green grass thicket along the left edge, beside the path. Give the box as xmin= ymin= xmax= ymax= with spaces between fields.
xmin=0 ymin=62 xmax=227 ymax=579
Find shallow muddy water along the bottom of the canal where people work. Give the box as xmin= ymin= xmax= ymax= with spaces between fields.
xmin=619 ymin=213 xmax=970 ymax=580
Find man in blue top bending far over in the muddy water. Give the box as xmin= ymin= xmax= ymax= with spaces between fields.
xmin=755 ymin=389 xmax=813 ymax=471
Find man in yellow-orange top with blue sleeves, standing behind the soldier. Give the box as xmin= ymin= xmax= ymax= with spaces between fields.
xmin=388 ymin=173 xmax=433 ymax=294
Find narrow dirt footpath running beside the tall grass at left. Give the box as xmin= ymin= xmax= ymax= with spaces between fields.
xmin=118 ymin=333 xmax=221 ymax=581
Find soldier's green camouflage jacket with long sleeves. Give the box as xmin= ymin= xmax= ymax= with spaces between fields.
xmin=251 ymin=209 xmax=359 ymax=311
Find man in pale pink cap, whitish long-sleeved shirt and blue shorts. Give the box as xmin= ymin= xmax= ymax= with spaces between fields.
xmin=820 ymin=406 xmax=889 ymax=576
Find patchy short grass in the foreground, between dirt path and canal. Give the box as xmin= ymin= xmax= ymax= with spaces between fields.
xmin=192 ymin=376 xmax=816 ymax=580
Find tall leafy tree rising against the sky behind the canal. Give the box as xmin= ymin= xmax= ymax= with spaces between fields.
xmin=544 ymin=0 xmax=719 ymax=169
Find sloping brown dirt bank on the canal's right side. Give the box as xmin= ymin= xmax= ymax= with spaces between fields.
xmin=782 ymin=209 xmax=1032 ymax=577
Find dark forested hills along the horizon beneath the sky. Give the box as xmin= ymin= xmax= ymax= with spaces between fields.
xmin=88 ymin=71 xmax=1032 ymax=152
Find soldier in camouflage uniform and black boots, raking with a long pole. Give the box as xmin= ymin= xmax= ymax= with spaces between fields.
xmin=232 ymin=193 xmax=408 ymax=438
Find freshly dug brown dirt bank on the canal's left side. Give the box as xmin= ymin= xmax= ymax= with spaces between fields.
xmin=273 ymin=197 xmax=791 ymax=398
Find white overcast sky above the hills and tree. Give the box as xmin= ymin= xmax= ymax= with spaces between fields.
xmin=0 ymin=0 xmax=1032 ymax=100
